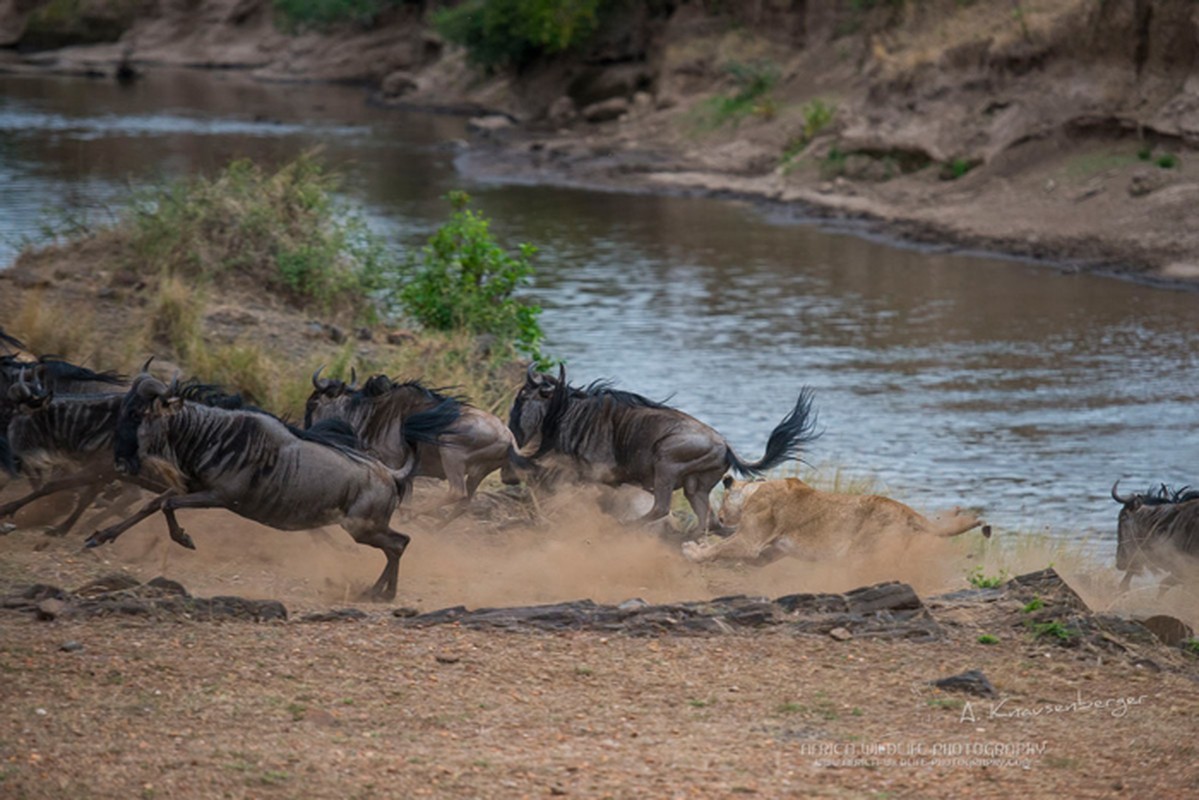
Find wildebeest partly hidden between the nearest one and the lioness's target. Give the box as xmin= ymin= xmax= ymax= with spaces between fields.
xmin=305 ymin=369 xmax=532 ymax=505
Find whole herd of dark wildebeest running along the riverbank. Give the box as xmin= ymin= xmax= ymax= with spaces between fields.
xmin=0 ymin=329 xmax=1199 ymax=600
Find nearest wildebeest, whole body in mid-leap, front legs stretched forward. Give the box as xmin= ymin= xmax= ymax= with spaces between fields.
xmin=86 ymin=374 xmax=456 ymax=600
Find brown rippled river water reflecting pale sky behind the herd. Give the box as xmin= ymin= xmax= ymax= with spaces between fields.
xmin=0 ymin=73 xmax=1199 ymax=554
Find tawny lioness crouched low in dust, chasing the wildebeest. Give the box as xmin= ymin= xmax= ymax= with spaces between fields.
xmin=682 ymin=477 xmax=990 ymax=563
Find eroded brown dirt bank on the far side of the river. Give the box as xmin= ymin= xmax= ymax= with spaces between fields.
xmin=8 ymin=0 xmax=1199 ymax=285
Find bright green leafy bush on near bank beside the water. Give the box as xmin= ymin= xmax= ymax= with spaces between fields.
xmin=399 ymin=192 xmax=543 ymax=361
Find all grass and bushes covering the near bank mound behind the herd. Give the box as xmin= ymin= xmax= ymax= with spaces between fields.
xmin=7 ymin=156 xmax=542 ymax=416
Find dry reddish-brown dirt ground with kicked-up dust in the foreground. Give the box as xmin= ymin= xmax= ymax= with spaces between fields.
xmin=0 ymin=487 xmax=1199 ymax=798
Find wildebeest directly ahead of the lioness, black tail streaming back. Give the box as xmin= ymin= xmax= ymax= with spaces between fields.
xmin=508 ymin=367 xmax=818 ymax=534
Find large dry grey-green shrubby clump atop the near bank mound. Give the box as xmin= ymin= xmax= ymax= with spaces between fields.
xmin=125 ymin=156 xmax=391 ymax=318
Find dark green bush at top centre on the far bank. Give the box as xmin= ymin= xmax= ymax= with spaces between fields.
xmin=433 ymin=0 xmax=609 ymax=70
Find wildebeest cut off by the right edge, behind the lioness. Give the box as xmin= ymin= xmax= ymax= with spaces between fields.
xmin=1111 ymin=481 xmax=1199 ymax=594
